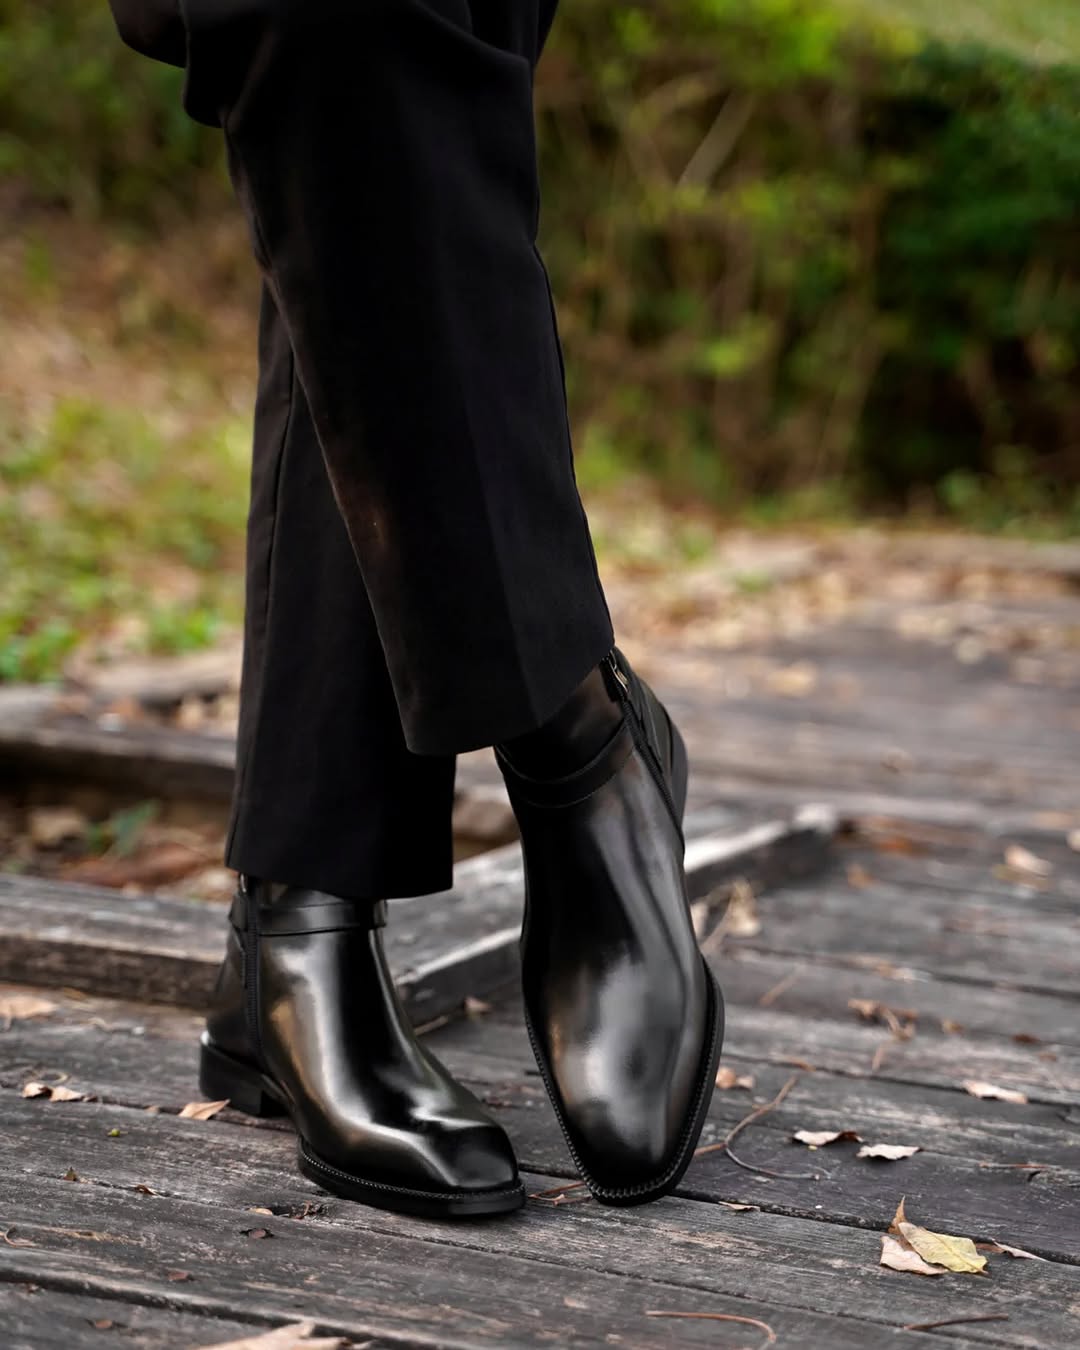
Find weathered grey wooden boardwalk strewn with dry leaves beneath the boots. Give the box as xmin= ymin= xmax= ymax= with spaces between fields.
xmin=0 ymin=542 xmax=1080 ymax=1350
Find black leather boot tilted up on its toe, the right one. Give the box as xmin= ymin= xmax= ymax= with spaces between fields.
xmin=498 ymin=651 xmax=724 ymax=1206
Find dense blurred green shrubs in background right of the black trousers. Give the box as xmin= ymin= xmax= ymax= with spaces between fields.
xmin=540 ymin=0 xmax=1080 ymax=510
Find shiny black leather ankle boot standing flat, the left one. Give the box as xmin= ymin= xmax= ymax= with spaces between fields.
xmin=200 ymin=878 xmax=525 ymax=1218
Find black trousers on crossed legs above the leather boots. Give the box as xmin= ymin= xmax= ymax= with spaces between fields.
xmin=111 ymin=0 xmax=613 ymax=896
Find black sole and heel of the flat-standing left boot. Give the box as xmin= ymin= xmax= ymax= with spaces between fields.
xmin=198 ymin=1031 xmax=525 ymax=1219
